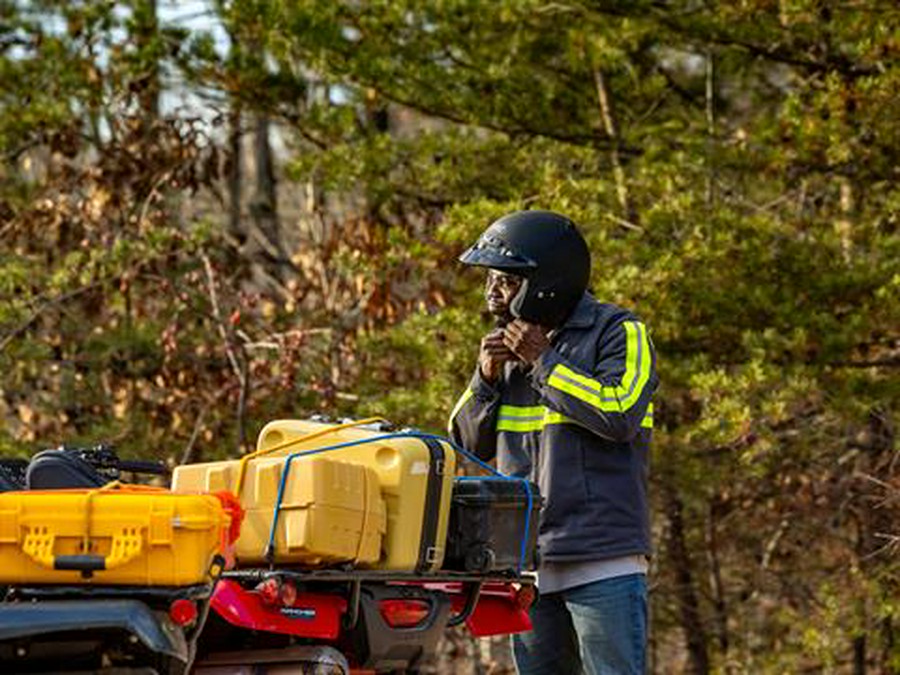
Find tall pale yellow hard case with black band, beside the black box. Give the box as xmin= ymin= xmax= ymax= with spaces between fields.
xmin=253 ymin=420 xmax=456 ymax=572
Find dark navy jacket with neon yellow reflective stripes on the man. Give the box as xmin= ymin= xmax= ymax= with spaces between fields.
xmin=449 ymin=294 xmax=658 ymax=560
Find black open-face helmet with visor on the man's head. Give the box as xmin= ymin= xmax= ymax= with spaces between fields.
xmin=459 ymin=211 xmax=591 ymax=326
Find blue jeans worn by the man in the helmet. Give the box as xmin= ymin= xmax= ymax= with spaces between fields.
xmin=513 ymin=574 xmax=647 ymax=675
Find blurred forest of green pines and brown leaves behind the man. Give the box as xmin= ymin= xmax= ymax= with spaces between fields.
xmin=0 ymin=0 xmax=900 ymax=675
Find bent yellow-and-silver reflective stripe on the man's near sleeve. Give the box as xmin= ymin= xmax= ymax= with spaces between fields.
xmin=547 ymin=321 xmax=651 ymax=412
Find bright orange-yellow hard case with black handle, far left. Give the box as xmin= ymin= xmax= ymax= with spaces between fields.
xmin=0 ymin=488 xmax=231 ymax=586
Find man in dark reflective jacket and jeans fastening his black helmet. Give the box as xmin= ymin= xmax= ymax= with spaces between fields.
xmin=449 ymin=211 xmax=658 ymax=675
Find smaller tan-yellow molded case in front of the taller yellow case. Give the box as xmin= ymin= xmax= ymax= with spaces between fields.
xmin=172 ymin=457 xmax=385 ymax=567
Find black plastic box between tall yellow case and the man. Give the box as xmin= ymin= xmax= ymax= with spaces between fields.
xmin=444 ymin=478 xmax=542 ymax=573
